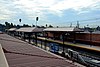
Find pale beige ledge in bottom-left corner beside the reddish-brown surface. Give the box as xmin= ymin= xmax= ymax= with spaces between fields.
xmin=0 ymin=44 xmax=9 ymax=67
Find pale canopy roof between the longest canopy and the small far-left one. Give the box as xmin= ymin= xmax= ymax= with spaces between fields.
xmin=16 ymin=27 xmax=43 ymax=32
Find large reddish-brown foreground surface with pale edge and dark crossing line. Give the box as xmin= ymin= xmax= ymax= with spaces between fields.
xmin=0 ymin=34 xmax=84 ymax=67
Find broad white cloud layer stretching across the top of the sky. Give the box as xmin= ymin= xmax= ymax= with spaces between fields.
xmin=0 ymin=0 xmax=100 ymax=19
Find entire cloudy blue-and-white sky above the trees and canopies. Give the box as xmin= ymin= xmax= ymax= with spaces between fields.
xmin=0 ymin=0 xmax=100 ymax=27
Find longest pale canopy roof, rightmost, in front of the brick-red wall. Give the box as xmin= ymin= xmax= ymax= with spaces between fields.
xmin=43 ymin=28 xmax=82 ymax=32
